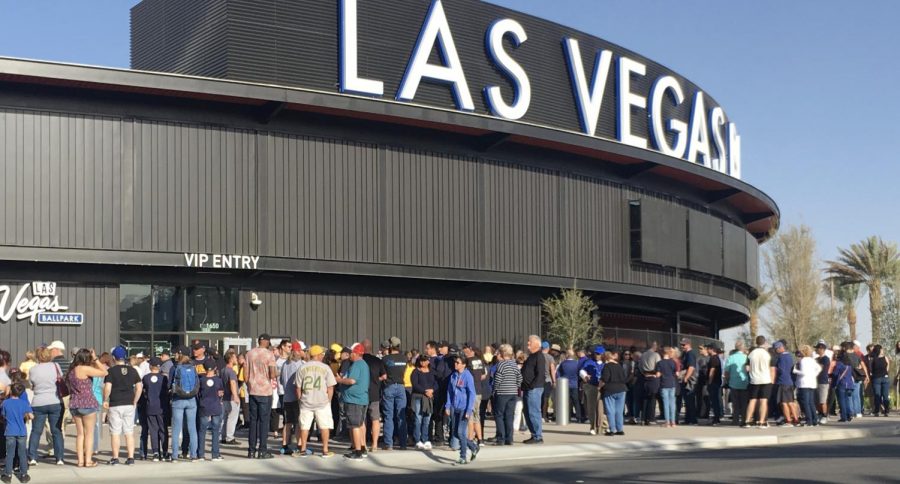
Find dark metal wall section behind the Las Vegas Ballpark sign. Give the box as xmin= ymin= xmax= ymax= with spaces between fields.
xmin=0 ymin=281 xmax=119 ymax=362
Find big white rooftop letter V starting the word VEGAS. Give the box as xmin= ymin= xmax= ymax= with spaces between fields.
xmin=563 ymin=38 xmax=612 ymax=136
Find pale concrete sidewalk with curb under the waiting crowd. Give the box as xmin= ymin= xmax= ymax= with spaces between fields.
xmin=15 ymin=417 xmax=900 ymax=483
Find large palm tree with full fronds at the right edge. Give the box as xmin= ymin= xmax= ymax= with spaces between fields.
xmin=826 ymin=236 xmax=900 ymax=341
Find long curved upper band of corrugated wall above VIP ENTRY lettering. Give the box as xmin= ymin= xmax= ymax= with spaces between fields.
xmin=0 ymin=109 xmax=756 ymax=308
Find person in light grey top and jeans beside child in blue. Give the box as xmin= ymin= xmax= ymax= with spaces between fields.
xmin=28 ymin=348 xmax=65 ymax=465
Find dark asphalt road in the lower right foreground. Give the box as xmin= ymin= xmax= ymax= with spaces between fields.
xmin=316 ymin=437 xmax=900 ymax=484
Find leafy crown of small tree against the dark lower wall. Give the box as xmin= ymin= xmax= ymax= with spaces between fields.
xmin=541 ymin=287 xmax=603 ymax=349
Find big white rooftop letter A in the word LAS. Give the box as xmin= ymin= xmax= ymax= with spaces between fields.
xmin=397 ymin=0 xmax=475 ymax=111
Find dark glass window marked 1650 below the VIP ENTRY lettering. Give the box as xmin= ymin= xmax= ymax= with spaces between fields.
xmin=185 ymin=287 xmax=238 ymax=333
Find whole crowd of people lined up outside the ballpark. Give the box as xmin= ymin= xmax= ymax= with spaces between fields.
xmin=0 ymin=334 xmax=900 ymax=482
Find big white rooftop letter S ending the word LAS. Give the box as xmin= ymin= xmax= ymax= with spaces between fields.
xmin=484 ymin=18 xmax=531 ymax=119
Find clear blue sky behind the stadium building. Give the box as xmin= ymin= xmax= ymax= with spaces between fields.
xmin=0 ymin=0 xmax=900 ymax=339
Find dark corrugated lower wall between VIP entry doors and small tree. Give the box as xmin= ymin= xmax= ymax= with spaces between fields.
xmin=242 ymin=291 xmax=540 ymax=349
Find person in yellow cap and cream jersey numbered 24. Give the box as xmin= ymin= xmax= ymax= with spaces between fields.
xmin=296 ymin=345 xmax=337 ymax=459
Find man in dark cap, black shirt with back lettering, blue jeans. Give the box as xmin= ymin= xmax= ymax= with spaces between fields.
xmin=381 ymin=336 xmax=407 ymax=450
